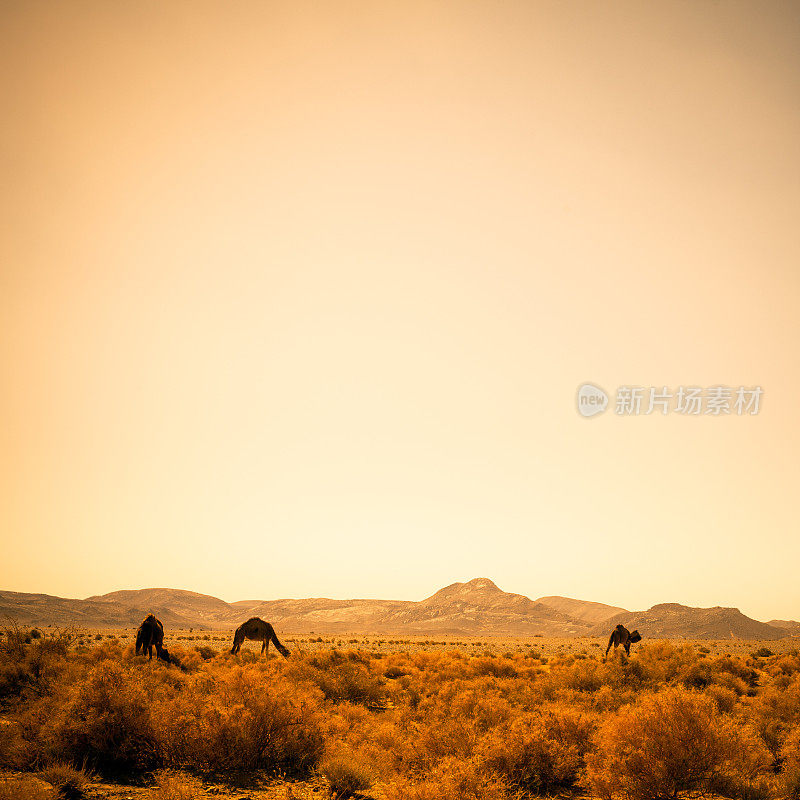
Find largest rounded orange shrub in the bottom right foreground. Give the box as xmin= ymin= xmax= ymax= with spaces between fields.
xmin=587 ymin=688 xmax=769 ymax=800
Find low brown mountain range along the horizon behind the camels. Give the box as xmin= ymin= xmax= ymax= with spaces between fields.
xmin=0 ymin=578 xmax=800 ymax=639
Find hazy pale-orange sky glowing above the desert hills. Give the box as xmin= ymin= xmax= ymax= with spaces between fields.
xmin=0 ymin=0 xmax=800 ymax=619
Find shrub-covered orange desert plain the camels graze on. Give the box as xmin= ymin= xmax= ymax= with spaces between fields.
xmin=0 ymin=626 xmax=800 ymax=800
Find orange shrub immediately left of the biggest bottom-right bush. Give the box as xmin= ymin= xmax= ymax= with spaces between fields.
xmin=479 ymin=707 xmax=593 ymax=794
